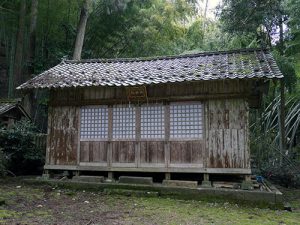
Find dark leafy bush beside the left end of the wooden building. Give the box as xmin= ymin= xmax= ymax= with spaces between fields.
xmin=0 ymin=120 xmax=44 ymax=174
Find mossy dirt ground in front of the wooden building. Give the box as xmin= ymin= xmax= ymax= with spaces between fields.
xmin=0 ymin=179 xmax=300 ymax=225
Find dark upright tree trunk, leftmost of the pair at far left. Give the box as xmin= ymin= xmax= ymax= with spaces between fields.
xmin=13 ymin=0 xmax=26 ymax=93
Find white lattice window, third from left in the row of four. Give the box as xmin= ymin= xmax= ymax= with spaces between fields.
xmin=141 ymin=105 xmax=165 ymax=138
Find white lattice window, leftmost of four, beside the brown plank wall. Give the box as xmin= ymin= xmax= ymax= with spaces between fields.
xmin=80 ymin=106 xmax=108 ymax=139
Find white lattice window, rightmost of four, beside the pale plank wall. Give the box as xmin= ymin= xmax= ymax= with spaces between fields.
xmin=170 ymin=103 xmax=202 ymax=138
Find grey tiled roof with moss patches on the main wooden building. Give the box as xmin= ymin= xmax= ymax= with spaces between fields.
xmin=18 ymin=49 xmax=283 ymax=89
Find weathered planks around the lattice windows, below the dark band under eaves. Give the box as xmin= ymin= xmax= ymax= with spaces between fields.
xmin=47 ymin=95 xmax=250 ymax=172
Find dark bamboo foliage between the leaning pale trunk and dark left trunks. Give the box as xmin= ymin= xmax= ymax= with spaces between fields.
xmin=34 ymin=0 xmax=81 ymax=73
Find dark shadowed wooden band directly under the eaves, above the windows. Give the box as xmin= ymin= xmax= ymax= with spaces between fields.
xmin=50 ymin=79 xmax=264 ymax=107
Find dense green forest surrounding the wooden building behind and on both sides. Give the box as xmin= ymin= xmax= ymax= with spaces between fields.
xmin=0 ymin=0 xmax=300 ymax=186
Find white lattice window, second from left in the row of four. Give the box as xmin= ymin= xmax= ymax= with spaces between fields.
xmin=113 ymin=106 xmax=135 ymax=139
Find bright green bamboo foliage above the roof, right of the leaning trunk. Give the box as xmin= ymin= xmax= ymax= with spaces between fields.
xmin=84 ymin=0 xmax=198 ymax=58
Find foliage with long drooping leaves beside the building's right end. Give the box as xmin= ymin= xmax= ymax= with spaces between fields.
xmin=250 ymin=93 xmax=300 ymax=186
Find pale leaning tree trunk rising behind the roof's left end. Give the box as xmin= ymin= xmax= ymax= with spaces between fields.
xmin=73 ymin=0 xmax=90 ymax=60
